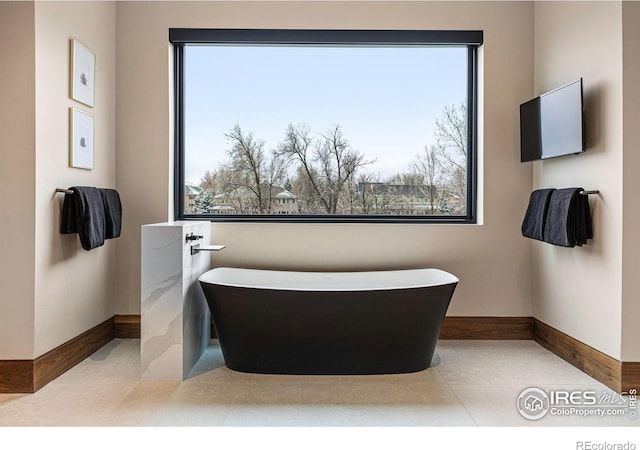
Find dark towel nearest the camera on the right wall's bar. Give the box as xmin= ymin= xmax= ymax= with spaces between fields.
xmin=544 ymin=187 xmax=593 ymax=247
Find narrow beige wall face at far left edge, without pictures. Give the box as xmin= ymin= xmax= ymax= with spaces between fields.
xmin=0 ymin=2 xmax=36 ymax=360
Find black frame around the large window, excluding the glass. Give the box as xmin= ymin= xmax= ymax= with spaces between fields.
xmin=169 ymin=28 xmax=483 ymax=224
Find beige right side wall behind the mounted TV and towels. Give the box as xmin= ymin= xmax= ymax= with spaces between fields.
xmin=532 ymin=2 xmax=624 ymax=359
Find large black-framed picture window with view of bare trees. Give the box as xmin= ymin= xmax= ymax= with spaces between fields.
xmin=170 ymin=29 xmax=482 ymax=223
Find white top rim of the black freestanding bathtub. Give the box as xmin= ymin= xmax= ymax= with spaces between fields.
xmin=199 ymin=267 xmax=459 ymax=292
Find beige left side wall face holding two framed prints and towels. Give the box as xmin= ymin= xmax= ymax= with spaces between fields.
xmin=34 ymin=2 xmax=116 ymax=355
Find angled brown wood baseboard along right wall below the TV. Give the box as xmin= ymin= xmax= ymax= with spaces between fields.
xmin=533 ymin=319 xmax=624 ymax=392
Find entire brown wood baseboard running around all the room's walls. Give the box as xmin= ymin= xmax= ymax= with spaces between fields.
xmin=0 ymin=315 xmax=640 ymax=394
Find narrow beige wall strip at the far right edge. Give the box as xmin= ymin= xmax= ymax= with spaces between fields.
xmin=622 ymin=2 xmax=640 ymax=361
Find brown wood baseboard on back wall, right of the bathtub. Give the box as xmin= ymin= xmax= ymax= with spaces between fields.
xmin=440 ymin=316 xmax=533 ymax=340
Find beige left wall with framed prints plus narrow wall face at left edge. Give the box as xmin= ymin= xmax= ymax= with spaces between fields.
xmin=0 ymin=2 xmax=116 ymax=360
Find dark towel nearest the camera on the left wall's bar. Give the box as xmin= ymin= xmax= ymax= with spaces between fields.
xmin=60 ymin=186 xmax=105 ymax=250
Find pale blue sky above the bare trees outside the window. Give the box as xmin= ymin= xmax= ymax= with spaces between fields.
xmin=185 ymin=45 xmax=467 ymax=185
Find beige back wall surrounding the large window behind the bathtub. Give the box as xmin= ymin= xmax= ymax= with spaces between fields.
xmin=116 ymin=1 xmax=533 ymax=316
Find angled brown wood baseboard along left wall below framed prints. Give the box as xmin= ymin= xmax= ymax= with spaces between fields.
xmin=33 ymin=317 xmax=115 ymax=391
